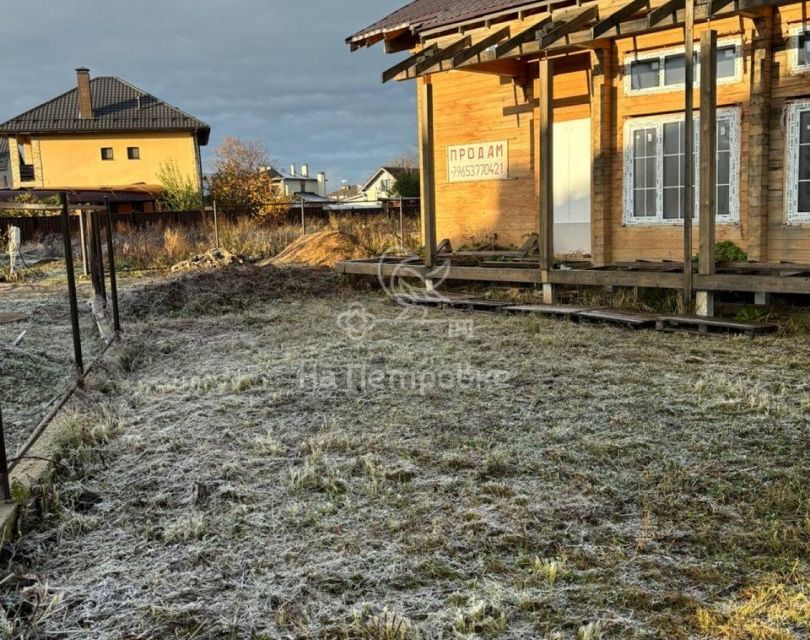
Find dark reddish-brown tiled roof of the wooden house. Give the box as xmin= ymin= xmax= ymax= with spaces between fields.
xmin=346 ymin=0 xmax=534 ymax=44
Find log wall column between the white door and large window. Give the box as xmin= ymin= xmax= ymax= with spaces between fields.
xmin=591 ymin=42 xmax=614 ymax=267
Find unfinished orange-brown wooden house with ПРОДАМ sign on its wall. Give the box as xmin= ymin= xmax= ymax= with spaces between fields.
xmin=341 ymin=0 xmax=810 ymax=312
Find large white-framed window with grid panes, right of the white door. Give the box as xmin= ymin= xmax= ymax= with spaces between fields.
xmin=624 ymin=110 xmax=740 ymax=224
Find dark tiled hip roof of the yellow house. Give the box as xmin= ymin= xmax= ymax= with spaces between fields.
xmin=0 ymin=76 xmax=211 ymax=144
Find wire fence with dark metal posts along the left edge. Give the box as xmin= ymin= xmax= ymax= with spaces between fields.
xmin=0 ymin=193 xmax=121 ymax=500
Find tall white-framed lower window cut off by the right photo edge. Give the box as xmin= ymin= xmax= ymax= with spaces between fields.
xmin=785 ymin=101 xmax=810 ymax=222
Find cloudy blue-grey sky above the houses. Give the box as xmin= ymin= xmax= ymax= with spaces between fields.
xmin=0 ymin=0 xmax=416 ymax=190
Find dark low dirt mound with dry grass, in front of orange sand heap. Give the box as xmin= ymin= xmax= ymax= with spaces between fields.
xmin=121 ymin=264 xmax=336 ymax=319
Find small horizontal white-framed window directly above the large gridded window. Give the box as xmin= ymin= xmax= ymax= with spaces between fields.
xmin=624 ymin=40 xmax=742 ymax=95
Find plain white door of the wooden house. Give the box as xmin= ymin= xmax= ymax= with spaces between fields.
xmin=554 ymin=118 xmax=591 ymax=254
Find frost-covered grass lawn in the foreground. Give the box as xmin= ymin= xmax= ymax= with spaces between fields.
xmin=0 ymin=272 xmax=810 ymax=640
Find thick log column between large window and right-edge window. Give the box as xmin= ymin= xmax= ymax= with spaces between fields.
xmin=745 ymin=7 xmax=773 ymax=262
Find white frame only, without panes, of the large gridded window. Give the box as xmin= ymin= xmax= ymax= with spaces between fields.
xmin=623 ymin=102 xmax=740 ymax=226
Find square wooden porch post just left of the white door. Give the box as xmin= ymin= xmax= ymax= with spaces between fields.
xmin=537 ymin=59 xmax=554 ymax=304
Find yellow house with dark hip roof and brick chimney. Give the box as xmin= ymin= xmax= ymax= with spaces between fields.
xmin=0 ymin=68 xmax=211 ymax=208
